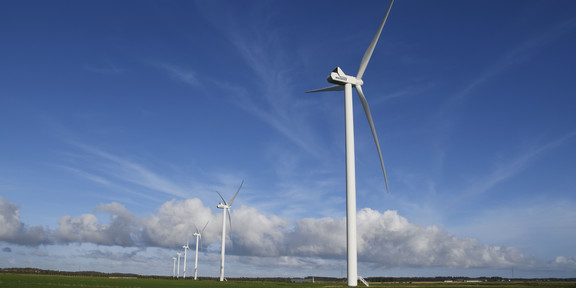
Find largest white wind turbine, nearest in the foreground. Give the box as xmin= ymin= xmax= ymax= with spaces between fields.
xmin=308 ymin=0 xmax=394 ymax=286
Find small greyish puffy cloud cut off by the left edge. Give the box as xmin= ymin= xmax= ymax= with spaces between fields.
xmin=0 ymin=196 xmax=49 ymax=245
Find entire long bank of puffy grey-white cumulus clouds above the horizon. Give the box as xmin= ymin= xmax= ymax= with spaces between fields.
xmin=0 ymin=198 xmax=548 ymax=268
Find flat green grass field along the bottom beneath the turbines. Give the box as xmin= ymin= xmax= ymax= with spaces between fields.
xmin=0 ymin=274 xmax=576 ymax=288
